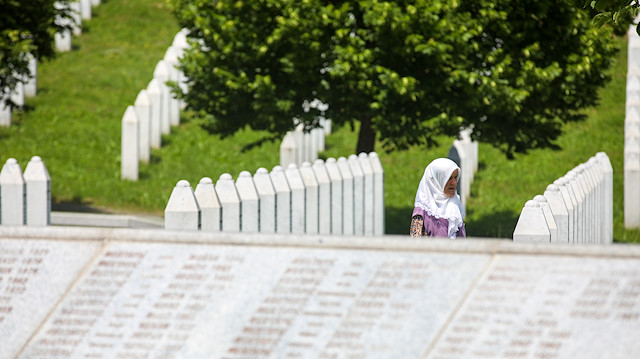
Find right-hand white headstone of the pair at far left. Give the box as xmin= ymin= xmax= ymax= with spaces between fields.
xmin=24 ymin=156 xmax=51 ymax=227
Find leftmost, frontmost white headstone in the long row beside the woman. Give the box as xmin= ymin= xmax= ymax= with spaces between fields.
xmin=164 ymin=180 xmax=200 ymax=231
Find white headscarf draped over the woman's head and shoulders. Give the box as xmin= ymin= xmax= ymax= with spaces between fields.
xmin=415 ymin=158 xmax=464 ymax=238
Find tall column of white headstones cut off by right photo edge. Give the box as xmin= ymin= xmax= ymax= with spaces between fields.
xmin=624 ymin=26 xmax=640 ymax=228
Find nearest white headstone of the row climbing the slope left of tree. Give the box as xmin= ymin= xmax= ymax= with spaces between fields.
xmin=120 ymin=106 xmax=140 ymax=181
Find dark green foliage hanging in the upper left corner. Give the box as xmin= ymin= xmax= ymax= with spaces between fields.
xmin=0 ymin=0 xmax=71 ymax=102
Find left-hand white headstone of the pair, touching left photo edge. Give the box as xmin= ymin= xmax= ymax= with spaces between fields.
xmin=0 ymin=158 xmax=25 ymax=226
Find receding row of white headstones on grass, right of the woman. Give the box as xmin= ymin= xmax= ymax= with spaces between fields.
xmin=513 ymin=152 xmax=613 ymax=244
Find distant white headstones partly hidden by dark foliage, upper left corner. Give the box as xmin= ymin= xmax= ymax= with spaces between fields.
xmin=0 ymin=0 xmax=100 ymax=127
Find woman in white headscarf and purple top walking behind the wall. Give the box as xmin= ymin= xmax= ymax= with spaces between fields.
xmin=411 ymin=158 xmax=466 ymax=239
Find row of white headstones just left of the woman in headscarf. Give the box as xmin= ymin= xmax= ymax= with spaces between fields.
xmin=165 ymin=152 xmax=384 ymax=236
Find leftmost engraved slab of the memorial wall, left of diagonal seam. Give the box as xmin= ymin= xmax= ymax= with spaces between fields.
xmin=0 ymin=239 xmax=101 ymax=358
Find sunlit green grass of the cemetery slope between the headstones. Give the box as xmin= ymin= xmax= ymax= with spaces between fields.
xmin=0 ymin=0 xmax=640 ymax=242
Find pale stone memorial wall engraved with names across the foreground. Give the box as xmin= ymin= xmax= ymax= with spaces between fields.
xmin=0 ymin=227 xmax=640 ymax=359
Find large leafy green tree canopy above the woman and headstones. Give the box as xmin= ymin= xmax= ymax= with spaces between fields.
xmin=172 ymin=0 xmax=615 ymax=156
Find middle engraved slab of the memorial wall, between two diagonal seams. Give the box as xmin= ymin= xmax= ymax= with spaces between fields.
xmin=19 ymin=243 xmax=490 ymax=359
